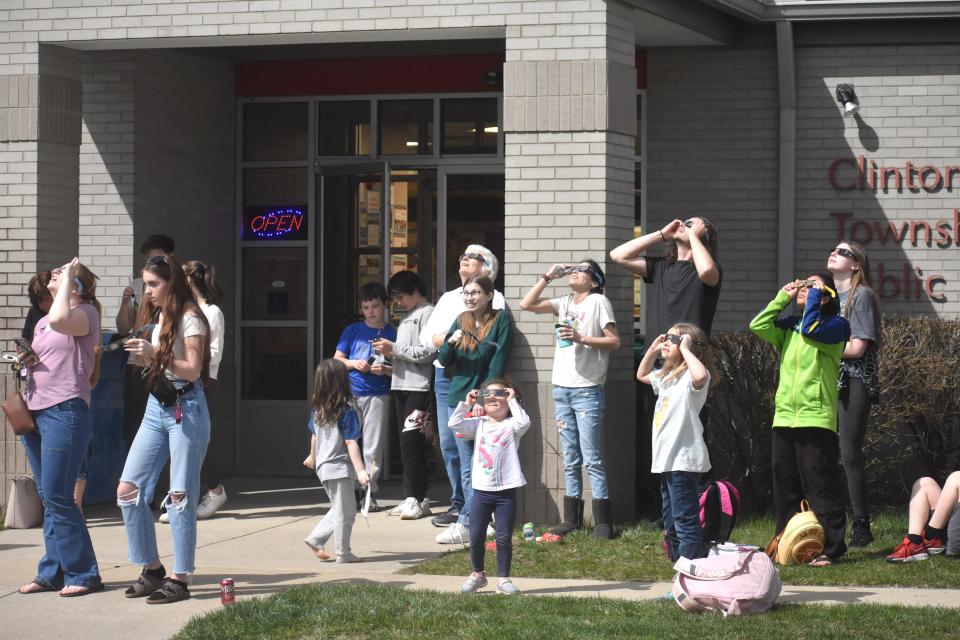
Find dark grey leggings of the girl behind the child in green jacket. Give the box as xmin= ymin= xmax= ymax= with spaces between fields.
xmin=837 ymin=376 xmax=870 ymax=518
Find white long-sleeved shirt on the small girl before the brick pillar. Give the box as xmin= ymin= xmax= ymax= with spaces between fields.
xmin=449 ymin=399 xmax=530 ymax=491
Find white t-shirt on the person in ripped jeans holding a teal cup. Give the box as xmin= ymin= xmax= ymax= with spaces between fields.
xmin=550 ymin=293 xmax=617 ymax=387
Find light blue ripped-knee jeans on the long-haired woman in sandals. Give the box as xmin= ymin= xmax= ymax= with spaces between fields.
xmin=117 ymin=381 xmax=210 ymax=573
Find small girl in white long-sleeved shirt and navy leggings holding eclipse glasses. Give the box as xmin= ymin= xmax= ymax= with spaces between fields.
xmin=449 ymin=378 xmax=530 ymax=595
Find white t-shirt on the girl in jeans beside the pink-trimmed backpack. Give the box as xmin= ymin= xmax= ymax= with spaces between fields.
xmin=650 ymin=369 xmax=710 ymax=473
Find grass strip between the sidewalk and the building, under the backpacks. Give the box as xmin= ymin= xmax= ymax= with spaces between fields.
xmin=407 ymin=513 xmax=960 ymax=588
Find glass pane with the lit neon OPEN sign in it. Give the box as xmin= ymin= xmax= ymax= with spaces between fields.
xmin=243 ymin=168 xmax=310 ymax=241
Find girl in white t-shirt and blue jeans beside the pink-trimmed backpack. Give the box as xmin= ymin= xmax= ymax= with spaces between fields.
xmin=637 ymin=323 xmax=717 ymax=561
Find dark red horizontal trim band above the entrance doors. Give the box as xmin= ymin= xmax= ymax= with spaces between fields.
xmin=234 ymin=53 xmax=504 ymax=97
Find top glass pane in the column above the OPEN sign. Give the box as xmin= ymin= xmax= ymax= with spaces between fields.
xmin=243 ymin=102 xmax=307 ymax=161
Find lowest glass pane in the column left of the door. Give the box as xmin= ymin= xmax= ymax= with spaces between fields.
xmin=242 ymin=327 xmax=307 ymax=400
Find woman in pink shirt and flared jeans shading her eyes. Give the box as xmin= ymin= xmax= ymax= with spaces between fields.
xmin=20 ymin=258 xmax=103 ymax=597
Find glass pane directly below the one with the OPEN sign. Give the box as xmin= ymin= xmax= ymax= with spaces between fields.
xmin=243 ymin=246 xmax=307 ymax=320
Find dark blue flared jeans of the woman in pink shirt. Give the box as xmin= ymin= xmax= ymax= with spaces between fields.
xmin=23 ymin=398 xmax=100 ymax=589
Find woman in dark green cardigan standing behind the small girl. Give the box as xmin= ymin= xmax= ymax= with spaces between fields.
xmin=437 ymin=276 xmax=513 ymax=544
